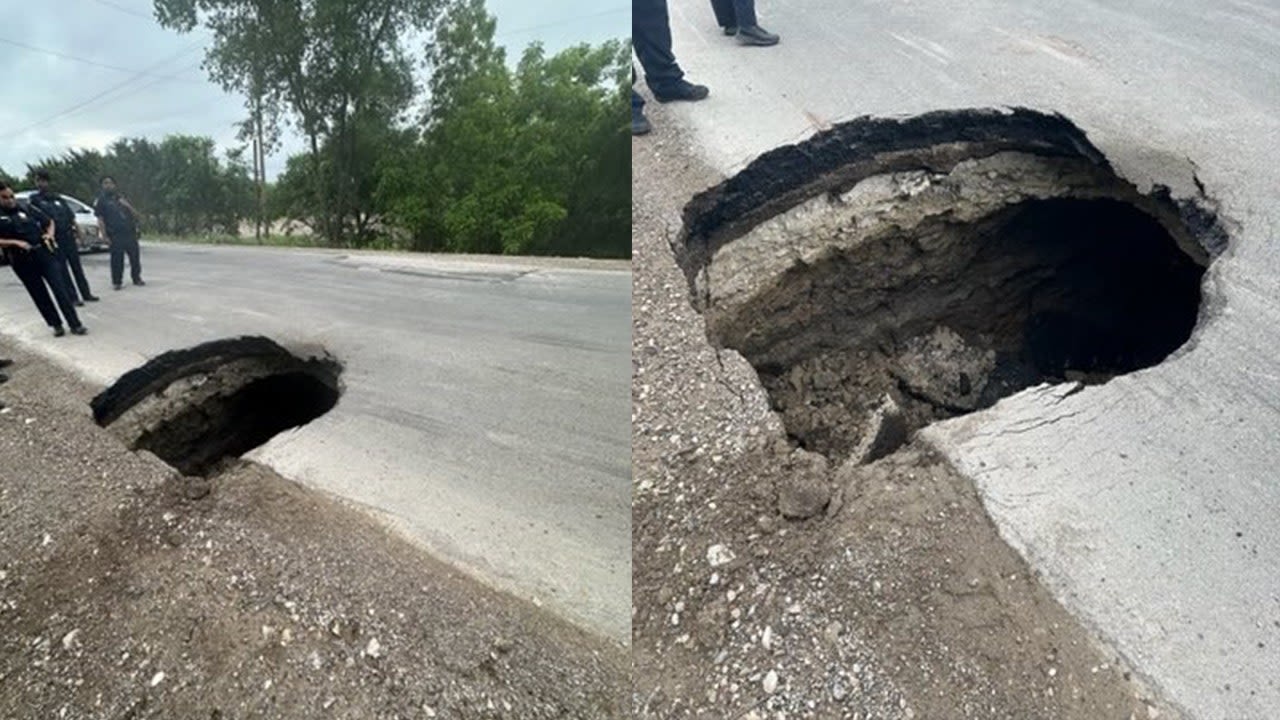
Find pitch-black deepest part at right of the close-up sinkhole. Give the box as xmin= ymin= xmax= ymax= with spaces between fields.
xmin=957 ymin=200 xmax=1204 ymax=382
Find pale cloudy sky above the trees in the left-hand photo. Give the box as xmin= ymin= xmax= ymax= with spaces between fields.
xmin=0 ymin=0 xmax=631 ymax=177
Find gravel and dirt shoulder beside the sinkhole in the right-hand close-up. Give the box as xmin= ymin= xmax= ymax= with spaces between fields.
xmin=632 ymin=99 xmax=1178 ymax=720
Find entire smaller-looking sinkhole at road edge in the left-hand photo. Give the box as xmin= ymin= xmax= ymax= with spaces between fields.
xmin=92 ymin=337 xmax=342 ymax=475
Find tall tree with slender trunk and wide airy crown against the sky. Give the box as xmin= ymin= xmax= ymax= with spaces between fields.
xmin=155 ymin=0 xmax=445 ymax=242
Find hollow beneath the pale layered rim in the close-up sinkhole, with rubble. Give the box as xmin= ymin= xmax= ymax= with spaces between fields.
xmin=746 ymin=199 xmax=1204 ymax=457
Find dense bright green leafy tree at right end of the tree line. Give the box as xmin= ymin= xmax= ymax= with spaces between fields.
xmin=376 ymin=0 xmax=631 ymax=256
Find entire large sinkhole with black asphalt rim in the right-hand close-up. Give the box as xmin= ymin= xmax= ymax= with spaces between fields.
xmin=673 ymin=109 xmax=1226 ymax=460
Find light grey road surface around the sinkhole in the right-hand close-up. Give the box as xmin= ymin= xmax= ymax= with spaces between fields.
xmin=655 ymin=0 xmax=1280 ymax=720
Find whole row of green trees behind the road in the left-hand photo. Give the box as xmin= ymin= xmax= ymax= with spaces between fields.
xmin=40 ymin=0 xmax=631 ymax=256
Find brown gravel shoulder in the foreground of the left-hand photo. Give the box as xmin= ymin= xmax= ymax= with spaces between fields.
xmin=0 ymin=338 xmax=630 ymax=720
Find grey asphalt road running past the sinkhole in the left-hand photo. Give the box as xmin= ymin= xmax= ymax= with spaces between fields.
xmin=0 ymin=245 xmax=631 ymax=642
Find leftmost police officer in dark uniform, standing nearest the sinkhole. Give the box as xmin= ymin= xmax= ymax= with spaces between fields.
xmin=0 ymin=182 xmax=88 ymax=337
